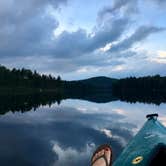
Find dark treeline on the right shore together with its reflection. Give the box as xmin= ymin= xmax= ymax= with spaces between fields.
xmin=113 ymin=75 xmax=166 ymax=104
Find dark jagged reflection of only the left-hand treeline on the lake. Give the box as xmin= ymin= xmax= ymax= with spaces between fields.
xmin=0 ymin=93 xmax=61 ymax=114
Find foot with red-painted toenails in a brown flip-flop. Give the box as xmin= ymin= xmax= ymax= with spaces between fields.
xmin=91 ymin=145 xmax=112 ymax=166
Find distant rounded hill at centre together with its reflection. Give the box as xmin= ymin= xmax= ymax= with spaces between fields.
xmin=63 ymin=76 xmax=117 ymax=103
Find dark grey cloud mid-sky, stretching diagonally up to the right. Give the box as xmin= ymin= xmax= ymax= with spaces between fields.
xmin=53 ymin=19 xmax=129 ymax=58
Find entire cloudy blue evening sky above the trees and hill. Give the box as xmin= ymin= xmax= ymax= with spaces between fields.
xmin=0 ymin=0 xmax=166 ymax=80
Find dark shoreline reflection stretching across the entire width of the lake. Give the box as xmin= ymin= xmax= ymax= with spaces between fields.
xmin=0 ymin=90 xmax=165 ymax=114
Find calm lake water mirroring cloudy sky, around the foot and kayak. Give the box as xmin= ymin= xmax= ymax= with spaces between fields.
xmin=0 ymin=99 xmax=166 ymax=166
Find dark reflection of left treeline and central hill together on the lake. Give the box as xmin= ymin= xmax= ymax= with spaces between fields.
xmin=0 ymin=91 xmax=116 ymax=114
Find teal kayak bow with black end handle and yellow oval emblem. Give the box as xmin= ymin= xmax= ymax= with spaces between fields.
xmin=113 ymin=114 xmax=166 ymax=166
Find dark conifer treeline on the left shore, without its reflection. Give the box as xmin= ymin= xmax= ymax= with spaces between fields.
xmin=0 ymin=66 xmax=61 ymax=89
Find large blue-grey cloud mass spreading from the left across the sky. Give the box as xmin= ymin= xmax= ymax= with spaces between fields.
xmin=0 ymin=0 xmax=164 ymax=76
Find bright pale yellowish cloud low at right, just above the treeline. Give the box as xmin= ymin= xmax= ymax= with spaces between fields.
xmin=107 ymin=52 xmax=166 ymax=78
